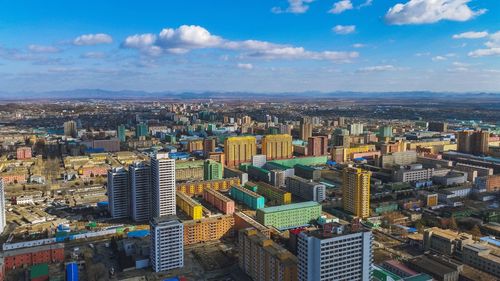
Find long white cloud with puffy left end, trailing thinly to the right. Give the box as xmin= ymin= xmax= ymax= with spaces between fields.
xmin=122 ymin=25 xmax=359 ymax=61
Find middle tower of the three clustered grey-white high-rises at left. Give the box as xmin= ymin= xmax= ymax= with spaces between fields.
xmin=128 ymin=162 xmax=151 ymax=221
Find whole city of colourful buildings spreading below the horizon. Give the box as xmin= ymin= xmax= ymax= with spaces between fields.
xmin=0 ymin=97 xmax=500 ymax=281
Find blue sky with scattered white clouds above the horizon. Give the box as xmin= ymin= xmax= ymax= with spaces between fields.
xmin=0 ymin=0 xmax=500 ymax=92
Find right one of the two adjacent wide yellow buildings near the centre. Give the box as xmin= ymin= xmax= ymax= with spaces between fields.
xmin=262 ymin=134 xmax=293 ymax=160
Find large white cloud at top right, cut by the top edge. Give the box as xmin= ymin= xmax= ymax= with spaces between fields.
xmin=385 ymin=0 xmax=486 ymax=25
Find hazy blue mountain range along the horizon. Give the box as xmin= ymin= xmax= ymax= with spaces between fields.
xmin=0 ymin=89 xmax=500 ymax=102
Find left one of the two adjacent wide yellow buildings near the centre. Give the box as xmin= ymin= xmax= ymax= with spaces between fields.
xmin=224 ymin=136 xmax=257 ymax=167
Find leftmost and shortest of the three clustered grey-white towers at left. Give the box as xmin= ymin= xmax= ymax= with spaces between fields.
xmin=108 ymin=167 xmax=130 ymax=219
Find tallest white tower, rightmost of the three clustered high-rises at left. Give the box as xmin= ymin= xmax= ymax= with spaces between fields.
xmin=151 ymin=153 xmax=175 ymax=218
